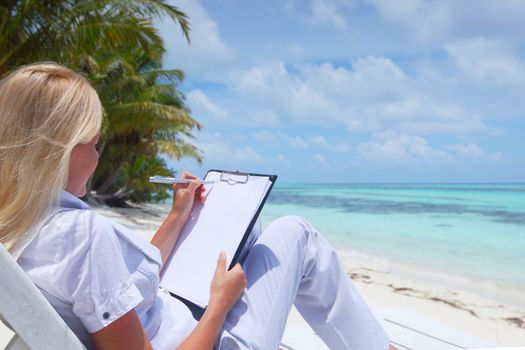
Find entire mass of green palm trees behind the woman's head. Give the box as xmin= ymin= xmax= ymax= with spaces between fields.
xmin=0 ymin=0 xmax=201 ymax=204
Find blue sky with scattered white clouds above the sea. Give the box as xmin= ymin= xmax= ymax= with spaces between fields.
xmin=158 ymin=0 xmax=525 ymax=183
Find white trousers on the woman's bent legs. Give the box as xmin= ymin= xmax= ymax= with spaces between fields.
xmin=216 ymin=216 xmax=389 ymax=350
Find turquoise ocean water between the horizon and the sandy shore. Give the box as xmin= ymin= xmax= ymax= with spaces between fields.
xmin=261 ymin=183 xmax=525 ymax=291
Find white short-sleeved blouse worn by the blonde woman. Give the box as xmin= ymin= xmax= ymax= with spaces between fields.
xmin=15 ymin=192 xmax=197 ymax=349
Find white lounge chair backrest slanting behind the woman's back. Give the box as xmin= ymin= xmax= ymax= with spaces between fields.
xmin=0 ymin=244 xmax=85 ymax=350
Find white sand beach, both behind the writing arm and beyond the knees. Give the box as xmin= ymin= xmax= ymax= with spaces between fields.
xmin=96 ymin=204 xmax=525 ymax=346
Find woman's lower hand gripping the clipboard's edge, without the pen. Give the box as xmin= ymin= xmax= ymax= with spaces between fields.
xmin=209 ymin=252 xmax=246 ymax=313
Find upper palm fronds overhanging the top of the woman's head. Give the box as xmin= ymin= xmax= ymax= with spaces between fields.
xmin=0 ymin=0 xmax=190 ymax=76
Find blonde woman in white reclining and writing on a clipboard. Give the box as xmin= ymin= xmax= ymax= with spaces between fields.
xmin=0 ymin=63 xmax=388 ymax=350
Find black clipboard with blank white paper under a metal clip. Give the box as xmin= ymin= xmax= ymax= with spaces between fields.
xmin=160 ymin=169 xmax=277 ymax=319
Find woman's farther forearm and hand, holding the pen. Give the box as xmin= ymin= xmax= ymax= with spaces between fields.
xmin=151 ymin=172 xmax=205 ymax=264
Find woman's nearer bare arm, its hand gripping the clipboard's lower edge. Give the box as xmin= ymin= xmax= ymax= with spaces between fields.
xmin=91 ymin=254 xmax=246 ymax=350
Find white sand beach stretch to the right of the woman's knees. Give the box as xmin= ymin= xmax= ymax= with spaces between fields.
xmin=341 ymin=252 xmax=525 ymax=346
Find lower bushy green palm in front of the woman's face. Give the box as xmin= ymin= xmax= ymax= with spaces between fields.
xmin=84 ymin=53 xmax=201 ymax=205
